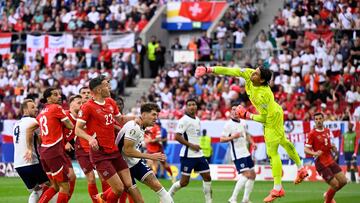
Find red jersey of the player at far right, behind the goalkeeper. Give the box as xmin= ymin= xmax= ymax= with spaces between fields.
xmin=305 ymin=128 xmax=335 ymax=167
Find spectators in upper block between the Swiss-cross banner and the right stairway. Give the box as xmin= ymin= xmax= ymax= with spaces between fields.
xmin=171 ymin=0 xmax=259 ymax=61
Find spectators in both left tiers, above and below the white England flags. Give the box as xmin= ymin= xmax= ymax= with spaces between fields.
xmin=0 ymin=0 xmax=160 ymax=119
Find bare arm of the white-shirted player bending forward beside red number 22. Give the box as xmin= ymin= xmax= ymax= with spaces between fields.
xmin=123 ymin=138 xmax=166 ymax=161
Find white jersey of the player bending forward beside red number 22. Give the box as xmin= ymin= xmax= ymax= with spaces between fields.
xmin=115 ymin=121 xmax=145 ymax=168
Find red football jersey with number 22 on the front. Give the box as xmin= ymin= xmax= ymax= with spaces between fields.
xmin=77 ymin=98 xmax=121 ymax=153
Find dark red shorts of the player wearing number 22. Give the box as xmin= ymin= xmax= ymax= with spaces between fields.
xmin=94 ymin=151 xmax=128 ymax=180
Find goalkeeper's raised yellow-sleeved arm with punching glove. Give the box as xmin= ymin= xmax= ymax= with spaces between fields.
xmin=195 ymin=66 xmax=255 ymax=80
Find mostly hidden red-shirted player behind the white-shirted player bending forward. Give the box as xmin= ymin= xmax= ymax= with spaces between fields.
xmin=145 ymin=120 xmax=176 ymax=182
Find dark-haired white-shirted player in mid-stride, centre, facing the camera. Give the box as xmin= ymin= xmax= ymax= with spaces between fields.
xmin=169 ymin=99 xmax=212 ymax=203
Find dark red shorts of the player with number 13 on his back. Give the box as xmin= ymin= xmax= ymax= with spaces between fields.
xmin=40 ymin=155 xmax=69 ymax=183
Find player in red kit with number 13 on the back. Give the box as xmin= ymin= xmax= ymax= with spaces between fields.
xmin=25 ymin=88 xmax=74 ymax=203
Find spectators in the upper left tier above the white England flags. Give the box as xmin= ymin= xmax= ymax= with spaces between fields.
xmin=0 ymin=0 xmax=159 ymax=33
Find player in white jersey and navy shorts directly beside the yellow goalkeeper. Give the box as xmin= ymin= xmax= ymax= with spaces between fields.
xmin=220 ymin=105 xmax=256 ymax=203
